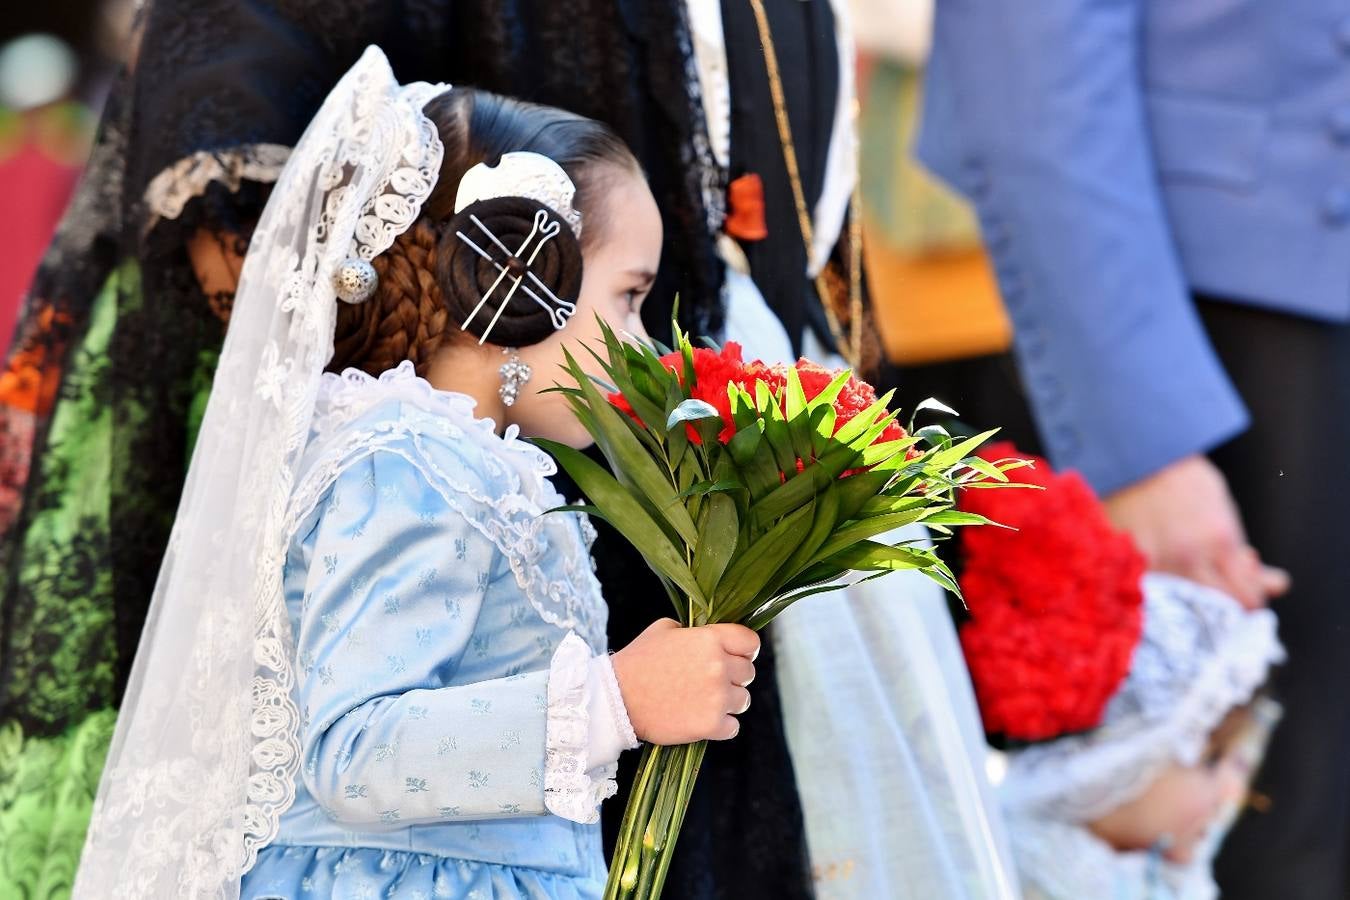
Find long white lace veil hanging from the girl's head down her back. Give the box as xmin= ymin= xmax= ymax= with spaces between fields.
xmin=74 ymin=47 xmax=444 ymax=900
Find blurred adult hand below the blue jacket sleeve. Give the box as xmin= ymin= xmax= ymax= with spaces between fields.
xmin=1106 ymin=455 xmax=1289 ymax=609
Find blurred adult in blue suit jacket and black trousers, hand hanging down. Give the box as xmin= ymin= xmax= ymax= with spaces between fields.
xmin=919 ymin=0 xmax=1350 ymax=900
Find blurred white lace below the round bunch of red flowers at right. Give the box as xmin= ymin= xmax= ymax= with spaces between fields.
xmin=999 ymin=575 xmax=1284 ymax=822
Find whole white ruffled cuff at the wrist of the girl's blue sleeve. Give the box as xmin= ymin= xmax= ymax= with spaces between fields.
xmin=544 ymin=633 xmax=637 ymax=824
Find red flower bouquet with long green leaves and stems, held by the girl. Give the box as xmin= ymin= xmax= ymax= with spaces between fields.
xmin=539 ymin=322 xmax=1011 ymax=899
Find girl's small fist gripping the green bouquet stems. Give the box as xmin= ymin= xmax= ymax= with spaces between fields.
xmin=612 ymin=619 xmax=760 ymax=743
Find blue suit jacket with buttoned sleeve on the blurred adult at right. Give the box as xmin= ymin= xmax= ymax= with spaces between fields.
xmin=919 ymin=0 xmax=1350 ymax=491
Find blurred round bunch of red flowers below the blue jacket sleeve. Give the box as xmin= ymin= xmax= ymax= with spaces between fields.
xmin=960 ymin=444 xmax=1145 ymax=741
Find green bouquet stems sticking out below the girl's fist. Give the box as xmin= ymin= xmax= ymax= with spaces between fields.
xmin=605 ymin=741 xmax=707 ymax=900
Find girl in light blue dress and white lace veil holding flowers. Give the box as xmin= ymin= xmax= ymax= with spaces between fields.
xmin=77 ymin=50 xmax=759 ymax=900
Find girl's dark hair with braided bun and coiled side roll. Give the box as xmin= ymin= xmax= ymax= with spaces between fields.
xmin=329 ymin=88 xmax=640 ymax=375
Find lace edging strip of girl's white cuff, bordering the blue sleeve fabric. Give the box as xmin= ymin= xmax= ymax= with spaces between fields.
xmin=544 ymin=634 xmax=628 ymax=824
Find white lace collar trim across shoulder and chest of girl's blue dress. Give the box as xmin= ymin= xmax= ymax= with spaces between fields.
xmin=286 ymin=362 xmax=608 ymax=652
